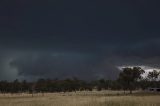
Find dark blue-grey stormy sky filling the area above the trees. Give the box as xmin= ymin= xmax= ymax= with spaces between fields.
xmin=0 ymin=0 xmax=160 ymax=80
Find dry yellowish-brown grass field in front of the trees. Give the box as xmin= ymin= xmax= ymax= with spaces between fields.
xmin=0 ymin=91 xmax=160 ymax=106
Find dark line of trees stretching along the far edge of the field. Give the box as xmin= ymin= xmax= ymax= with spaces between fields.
xmin=0 ymin=67 xmax=160 ymax=94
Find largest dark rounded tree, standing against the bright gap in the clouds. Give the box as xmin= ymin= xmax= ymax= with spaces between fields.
xmin=118 ymin=67 xmax=145 ymax=94
